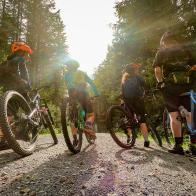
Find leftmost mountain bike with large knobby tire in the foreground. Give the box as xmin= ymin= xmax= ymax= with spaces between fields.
xmin=0 ymin=87 xmax=58 ymax=156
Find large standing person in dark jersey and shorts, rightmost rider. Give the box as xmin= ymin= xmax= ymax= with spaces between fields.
xmin=153 ymin=31 xmax=196 ymax=155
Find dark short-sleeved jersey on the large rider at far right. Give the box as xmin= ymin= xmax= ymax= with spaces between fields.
xmin=153 ymin=45 xmax=196 ymax=95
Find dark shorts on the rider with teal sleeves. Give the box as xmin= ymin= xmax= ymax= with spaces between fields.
xmin=69 ymin=88 xmax=93 ymax=113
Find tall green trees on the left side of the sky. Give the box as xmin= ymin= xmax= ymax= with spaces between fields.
xmin=0 ymin=0 xmax=68 ymax=127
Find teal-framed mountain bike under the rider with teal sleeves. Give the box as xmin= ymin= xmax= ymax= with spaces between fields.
xmin=61 ymin=97 xmax=95 ymax=154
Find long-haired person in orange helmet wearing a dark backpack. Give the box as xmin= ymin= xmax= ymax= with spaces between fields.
xmin=121 ymin=63 xmax=150 ymax=147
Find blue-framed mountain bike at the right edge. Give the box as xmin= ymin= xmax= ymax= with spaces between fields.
xmin=163 ymin=90 xmax=196 ymax=148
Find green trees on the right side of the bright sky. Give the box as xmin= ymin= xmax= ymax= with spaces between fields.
xmin=95 ymin=0 xmax=196 ymax=103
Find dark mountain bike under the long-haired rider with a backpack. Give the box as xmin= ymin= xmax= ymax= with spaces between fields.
xmin=107 ymin=94 xmax=162 ymax=149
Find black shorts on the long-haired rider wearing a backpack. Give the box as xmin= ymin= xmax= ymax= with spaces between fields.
xmin=124 ymin=98 xmax=146 ymax=123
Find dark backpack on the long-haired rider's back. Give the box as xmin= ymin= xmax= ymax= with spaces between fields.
xmin=122 ymin=77 xmax=144 ymax=99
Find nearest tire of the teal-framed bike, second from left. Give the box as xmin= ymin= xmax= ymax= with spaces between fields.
xmin=60 ymin=101 xmax=82 ymax=154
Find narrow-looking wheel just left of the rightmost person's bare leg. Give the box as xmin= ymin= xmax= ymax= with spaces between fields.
xmin=163 ymin=108 xmax=174 ymax=146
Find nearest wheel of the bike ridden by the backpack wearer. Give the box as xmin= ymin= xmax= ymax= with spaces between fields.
xmin=107 ymin=105 xmax=136 ymax=149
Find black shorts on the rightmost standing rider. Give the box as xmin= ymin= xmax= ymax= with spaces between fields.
xmin=163 ymin=85 xmax=191 ymax=112
